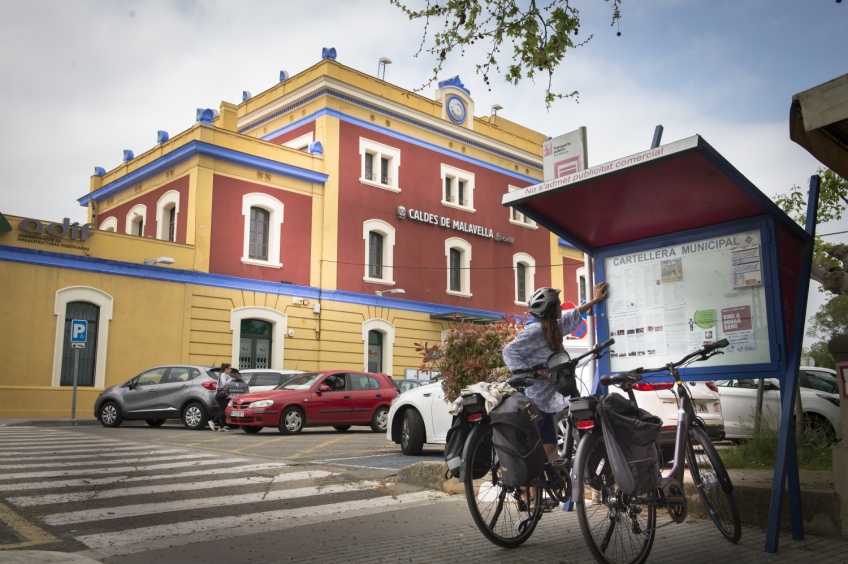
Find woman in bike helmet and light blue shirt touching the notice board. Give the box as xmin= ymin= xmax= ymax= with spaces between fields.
xmin=503 ymin=282 xmax=608 ymax=458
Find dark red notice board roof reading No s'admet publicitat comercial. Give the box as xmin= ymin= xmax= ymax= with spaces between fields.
xmin=503 ymin=135 xmax=810 ymax=254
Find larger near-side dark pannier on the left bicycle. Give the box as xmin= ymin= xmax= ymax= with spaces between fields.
xmin=489 ymin=393 xmax=546 ymax=487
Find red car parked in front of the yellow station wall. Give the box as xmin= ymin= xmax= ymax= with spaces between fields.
xmin=226 ymin=370 xmax=398 ymax=435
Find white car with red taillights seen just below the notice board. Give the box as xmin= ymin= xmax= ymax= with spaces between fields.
xmin=610 ymin=380 xmax=725 ymax=452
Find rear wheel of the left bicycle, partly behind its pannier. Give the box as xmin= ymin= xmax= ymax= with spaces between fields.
xmin=463 ymin=424 xmax=542 ymax=548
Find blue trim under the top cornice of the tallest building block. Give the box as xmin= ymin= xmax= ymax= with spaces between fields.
xmin=239 ymin=89 xmax=542 ymax=174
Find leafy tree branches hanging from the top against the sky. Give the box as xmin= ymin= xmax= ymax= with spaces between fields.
xmin=389 ymin=0 xmax=621 ymax=107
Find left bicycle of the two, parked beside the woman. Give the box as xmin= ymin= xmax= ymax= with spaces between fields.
xmin=462 ymin=340 xmax=614 ymax=548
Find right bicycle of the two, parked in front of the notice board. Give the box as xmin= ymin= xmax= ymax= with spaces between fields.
xmin=573 ymin=339 xmax=742 ymax=564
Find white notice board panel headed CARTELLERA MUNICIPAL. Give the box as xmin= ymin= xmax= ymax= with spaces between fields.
xmin=596 ymin=221 xmax=776 ymax=372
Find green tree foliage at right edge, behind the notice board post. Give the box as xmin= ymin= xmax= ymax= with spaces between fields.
xmin=775 ymin=168 xmax=848 ymax=296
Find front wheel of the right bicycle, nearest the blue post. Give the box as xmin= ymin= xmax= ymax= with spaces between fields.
xmin=686 ymin=425 xmax=742 ymax=543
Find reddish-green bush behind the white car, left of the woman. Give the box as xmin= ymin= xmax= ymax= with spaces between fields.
xmin=415 ymin=317 xmax=524 ymax=401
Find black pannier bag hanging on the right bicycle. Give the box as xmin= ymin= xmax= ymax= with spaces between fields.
xmin=597 ymin=394 xmax=662 ymax=495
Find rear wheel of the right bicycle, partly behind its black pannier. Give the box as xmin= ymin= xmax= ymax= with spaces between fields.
xmin=572 ymin=429 xmax=657 ymax=564
